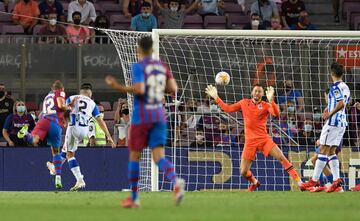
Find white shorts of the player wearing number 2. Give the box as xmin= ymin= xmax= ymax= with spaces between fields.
xmin=63 ymin=126 xmax=89 ymax=152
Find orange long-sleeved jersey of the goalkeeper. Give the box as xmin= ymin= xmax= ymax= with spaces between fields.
xmin=216 ymin=97 xmax=280 ymax=140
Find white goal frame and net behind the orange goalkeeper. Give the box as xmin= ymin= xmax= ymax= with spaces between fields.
xmin=105 ymin=30 xmax=360 ymax=191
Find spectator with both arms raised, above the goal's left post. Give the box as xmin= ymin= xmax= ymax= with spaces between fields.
xmin=155 ymin=0 xmax=198 ymax=29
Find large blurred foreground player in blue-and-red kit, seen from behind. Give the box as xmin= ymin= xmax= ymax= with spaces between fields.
xmin=105 ymin=37 xmax=185 ymax=208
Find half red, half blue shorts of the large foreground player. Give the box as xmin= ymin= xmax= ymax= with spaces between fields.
xmin=128 ymin=122 xmax=167 ymax=151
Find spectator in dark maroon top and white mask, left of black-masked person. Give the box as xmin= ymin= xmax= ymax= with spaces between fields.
xmin=38 ymin=13 xmax=66 ymax=44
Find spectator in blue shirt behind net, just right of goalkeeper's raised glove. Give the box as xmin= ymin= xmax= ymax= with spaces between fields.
xmin=278 ymin=80 xmax=304 ymax=112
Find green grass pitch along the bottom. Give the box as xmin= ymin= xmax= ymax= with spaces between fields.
xmin=0 ymin=191 xmax=360 ymax=221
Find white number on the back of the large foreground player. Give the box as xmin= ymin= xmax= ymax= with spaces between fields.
xmin=147 ymin=74 xmax=166 ymax=103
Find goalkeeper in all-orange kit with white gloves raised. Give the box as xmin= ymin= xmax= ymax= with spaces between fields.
xmin=205 ymin=85 xmax=302 ymax=192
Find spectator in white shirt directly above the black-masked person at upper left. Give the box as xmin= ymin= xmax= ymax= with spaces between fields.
xmin=68 ymin=0 xmax=96 ymax=25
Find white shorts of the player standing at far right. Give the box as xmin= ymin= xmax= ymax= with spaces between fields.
xmin=320 ymin=123 xmax=346 ymax=147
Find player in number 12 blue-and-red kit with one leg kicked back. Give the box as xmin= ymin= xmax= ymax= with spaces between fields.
xmin=18 ymin=80 xmax=75 ymax=189
